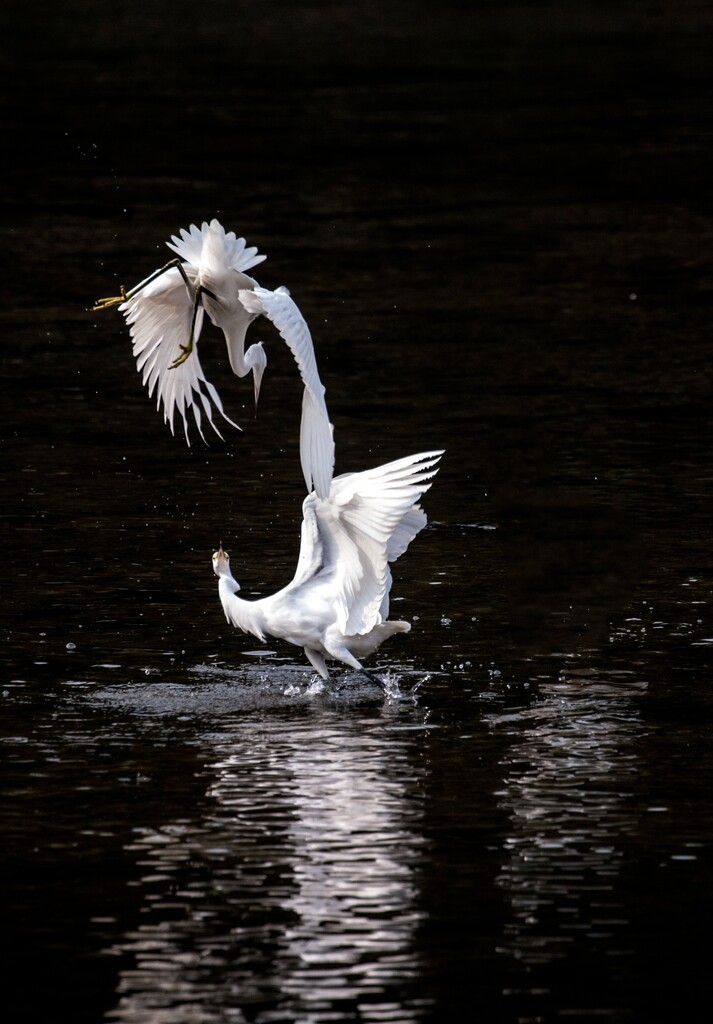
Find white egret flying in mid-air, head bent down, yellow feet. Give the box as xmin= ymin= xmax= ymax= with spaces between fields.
xmin=93 ymin=220 xmax=334 ymax=497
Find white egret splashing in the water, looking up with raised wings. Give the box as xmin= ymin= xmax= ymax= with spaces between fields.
xmin=213 ymin=451 xmax=443 ymax=686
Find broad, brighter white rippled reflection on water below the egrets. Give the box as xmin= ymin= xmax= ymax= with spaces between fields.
xmin=109 ymin=709 xmax=423 ymax=1024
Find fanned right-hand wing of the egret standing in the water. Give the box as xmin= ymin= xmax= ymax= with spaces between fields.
xmin=315 ymin=451 xmax=443 ymax=636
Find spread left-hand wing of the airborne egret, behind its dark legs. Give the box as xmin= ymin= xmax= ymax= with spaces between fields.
xmin=119 ymin=264 xmax=240 ymax=444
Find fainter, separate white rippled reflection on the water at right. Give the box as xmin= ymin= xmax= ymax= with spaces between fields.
xmin=490 ymin=673 xmax=645 ymax=983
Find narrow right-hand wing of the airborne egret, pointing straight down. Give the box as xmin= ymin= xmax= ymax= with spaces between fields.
xmin=240 ymin=287 xmax=334 ymax=498
